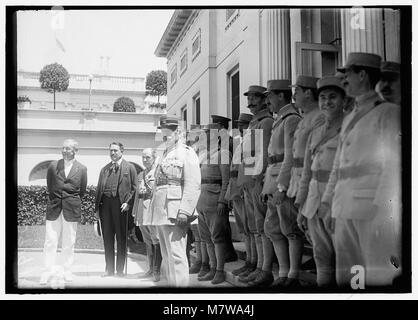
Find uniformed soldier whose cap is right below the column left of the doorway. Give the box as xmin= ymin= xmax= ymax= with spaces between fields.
xmin=260 ymin=80 xmax=301 ymax=287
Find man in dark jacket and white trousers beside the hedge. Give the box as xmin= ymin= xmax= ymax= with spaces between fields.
xmin=40 ymin=139 xmax=87 ymax=285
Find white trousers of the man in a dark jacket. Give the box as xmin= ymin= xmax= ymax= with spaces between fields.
xmin=44 ymin=211 xmax=77 ymax=272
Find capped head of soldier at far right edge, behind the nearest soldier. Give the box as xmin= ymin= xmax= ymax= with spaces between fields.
xmin=378 ymin=61 xmax=401 ymax=106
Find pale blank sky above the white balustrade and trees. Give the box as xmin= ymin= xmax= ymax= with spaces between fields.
xmin=17 ymin=10 xmax=174 ymax=77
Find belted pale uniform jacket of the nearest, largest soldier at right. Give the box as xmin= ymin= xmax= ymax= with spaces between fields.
xmin=322 ymin=91 xmax=401 ymax=219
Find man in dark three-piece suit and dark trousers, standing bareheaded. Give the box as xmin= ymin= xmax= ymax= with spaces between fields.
xmin=95 ymin=142 xmax=137 ymax=277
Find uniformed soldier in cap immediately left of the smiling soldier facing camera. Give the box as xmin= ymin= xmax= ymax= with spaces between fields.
xmin=275 ymin=75 xmax=323 ymax=288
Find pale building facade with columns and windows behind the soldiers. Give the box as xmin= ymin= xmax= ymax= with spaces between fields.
xmin=155 ymin=7 xmax=401 ymax=126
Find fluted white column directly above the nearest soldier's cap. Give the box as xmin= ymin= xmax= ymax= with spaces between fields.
xmin=341 ymin=8 xmax=385 ymax=64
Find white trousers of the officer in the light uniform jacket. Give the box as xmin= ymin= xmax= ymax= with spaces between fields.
xmin=157 ymin=225 xmax=189 ymax=287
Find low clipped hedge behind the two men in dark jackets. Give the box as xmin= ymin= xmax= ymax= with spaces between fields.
xmin=17 ymin=186 xmax=96 ymax=226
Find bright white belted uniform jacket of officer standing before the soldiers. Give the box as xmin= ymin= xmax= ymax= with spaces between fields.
xmin=150 ymin=141 xmax=201 ymax=225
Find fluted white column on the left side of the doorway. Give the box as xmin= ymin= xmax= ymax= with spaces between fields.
xmin=265 ymin=9 xmax=291 ymax=80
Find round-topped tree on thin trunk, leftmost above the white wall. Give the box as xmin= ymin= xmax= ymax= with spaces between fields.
xmin=39 ymin=62 xmax=70 ymax=110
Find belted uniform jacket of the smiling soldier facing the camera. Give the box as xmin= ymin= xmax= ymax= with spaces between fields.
xmin=295 ymin=117 xmax=343 ymax=219
